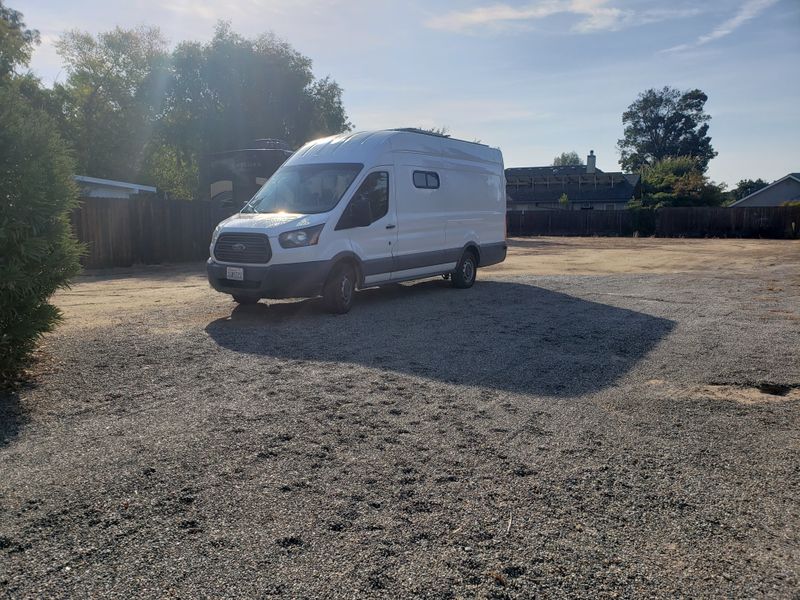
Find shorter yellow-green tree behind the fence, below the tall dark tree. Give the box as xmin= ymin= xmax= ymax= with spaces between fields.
xmin=633 ymin=156 xmax=725 ymax=208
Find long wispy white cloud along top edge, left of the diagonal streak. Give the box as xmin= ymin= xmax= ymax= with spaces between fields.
xmin=425 ymin=0 xmax=701 ymax=33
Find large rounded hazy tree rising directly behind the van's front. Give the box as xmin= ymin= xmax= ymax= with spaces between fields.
xmin=158 ymin=23 xmax=352 ymax=197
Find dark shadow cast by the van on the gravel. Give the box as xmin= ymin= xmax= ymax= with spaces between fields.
xmin=206 ymin=280 xmax=674 ymax=396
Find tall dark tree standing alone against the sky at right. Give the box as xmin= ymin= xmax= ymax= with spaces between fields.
xmin=617 ymin=87 xmax=717 ymax=172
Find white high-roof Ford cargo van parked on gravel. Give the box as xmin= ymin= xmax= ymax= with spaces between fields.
xmin=208 ymin=129 xmax=507 ymax=313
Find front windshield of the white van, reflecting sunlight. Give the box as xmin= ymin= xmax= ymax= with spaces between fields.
xmin=242 ymin=163 xmax=364 ymax=215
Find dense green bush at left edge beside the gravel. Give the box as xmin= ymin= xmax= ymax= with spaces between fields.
xmin=0 ymin=84 xmax=81 ymax=387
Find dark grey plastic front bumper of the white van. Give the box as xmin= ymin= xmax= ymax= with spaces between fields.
xmin=206 ymin=258 xmax=330 ymax=298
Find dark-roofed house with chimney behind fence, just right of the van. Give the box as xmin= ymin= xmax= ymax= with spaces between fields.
xmin=506 ymin=150 xmax=640 ymax=210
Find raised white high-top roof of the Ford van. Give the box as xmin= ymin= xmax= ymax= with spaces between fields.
xmin=287 ymin=129 xmax=503 ymax=169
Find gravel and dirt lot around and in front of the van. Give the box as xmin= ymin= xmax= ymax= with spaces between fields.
xmin=0 ymin=238 xmax=800 ymax=598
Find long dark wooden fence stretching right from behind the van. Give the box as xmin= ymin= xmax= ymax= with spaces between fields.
xmin=507 ymin=206 xmax=800 ymax=238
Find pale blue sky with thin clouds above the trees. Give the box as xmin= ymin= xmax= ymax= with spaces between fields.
xmin=15 ymin=0 xmax=800 ymax=186
